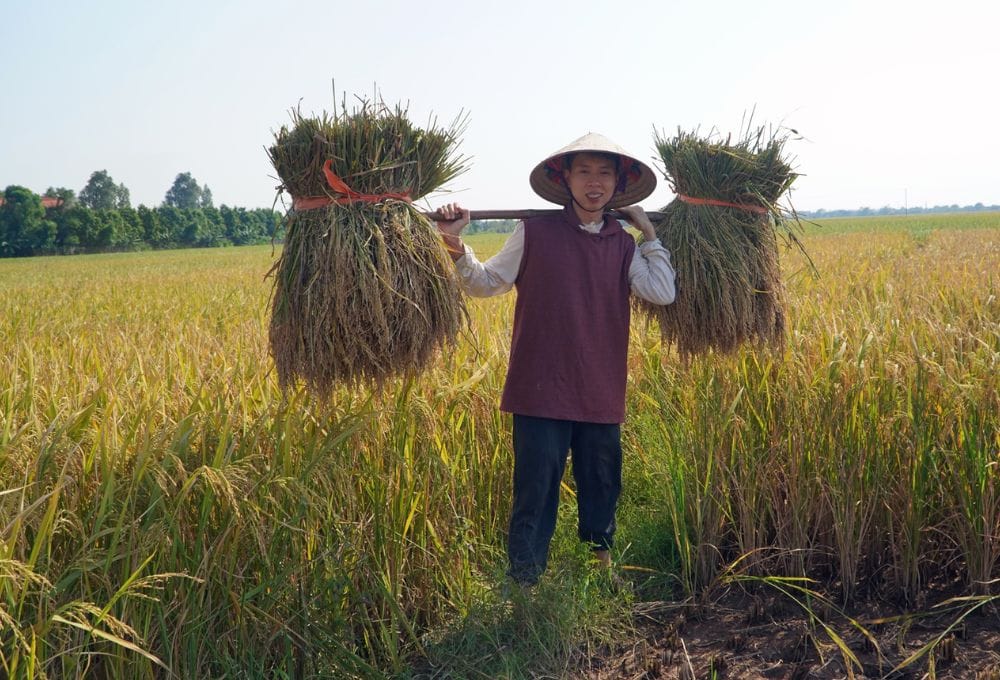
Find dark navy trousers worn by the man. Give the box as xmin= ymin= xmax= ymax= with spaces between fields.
xmin=507 ymin=414 xmax=622 ymax=584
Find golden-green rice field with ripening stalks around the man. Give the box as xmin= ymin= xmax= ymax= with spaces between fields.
xmin=0 ymin=213 xmax=1000 ymax=678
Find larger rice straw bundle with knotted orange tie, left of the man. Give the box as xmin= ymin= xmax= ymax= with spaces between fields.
xmin=268 ymin=100 xmax=467 ymax=396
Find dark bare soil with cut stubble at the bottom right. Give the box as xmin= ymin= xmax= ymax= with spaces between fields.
xmin=577 ymin=588 xmax=1000 ymax=680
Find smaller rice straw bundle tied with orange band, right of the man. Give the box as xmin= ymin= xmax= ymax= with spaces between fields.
xmin=641 ymin=127 xmax=801 ymax=359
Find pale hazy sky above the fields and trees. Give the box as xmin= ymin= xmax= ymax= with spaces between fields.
xmin=0 ymin=0 xmax=1000 ymax=210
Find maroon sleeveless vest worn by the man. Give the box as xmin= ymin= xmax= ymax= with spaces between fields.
xmin=500 ymin=207 xmax=635 ymax=423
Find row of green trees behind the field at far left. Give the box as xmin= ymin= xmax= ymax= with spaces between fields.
xmin=0 ymin=170 xmax=283 ymax=257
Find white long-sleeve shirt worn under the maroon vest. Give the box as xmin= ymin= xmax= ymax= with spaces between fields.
xmin=455 ymin=221 xmax=676 ymax=305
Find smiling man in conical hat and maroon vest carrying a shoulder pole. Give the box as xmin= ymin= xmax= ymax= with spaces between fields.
xmin=438 ymin=134 xmax=675 ymax=585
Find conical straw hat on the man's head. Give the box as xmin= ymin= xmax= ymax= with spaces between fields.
xmin=529 ymin=132 xmax=656 ymax=208
